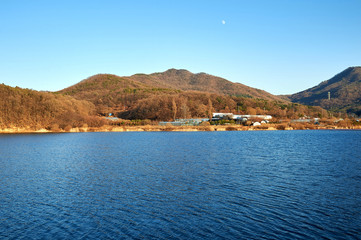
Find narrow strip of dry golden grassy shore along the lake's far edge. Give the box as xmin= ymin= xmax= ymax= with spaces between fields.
xmin=0 ymin=124 xmax=361 ymax=134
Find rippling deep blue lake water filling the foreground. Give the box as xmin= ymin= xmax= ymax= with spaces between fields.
xmin=0 ymin=130 xmax=361 ymax=239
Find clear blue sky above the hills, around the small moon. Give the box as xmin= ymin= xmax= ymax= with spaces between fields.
xmin=0 ymin=0 xmax=361 ymax=94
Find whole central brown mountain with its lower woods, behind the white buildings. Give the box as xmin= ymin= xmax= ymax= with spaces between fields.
xmin=58 ymin=69 xmax=321 ymax=120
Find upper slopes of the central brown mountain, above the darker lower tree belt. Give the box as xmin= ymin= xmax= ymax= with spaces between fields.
xmin=59 ymin=69 xmax=285 ymax=112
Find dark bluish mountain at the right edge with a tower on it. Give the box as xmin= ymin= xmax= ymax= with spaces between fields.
xmin=287 ymin=67 xmax=361 ymax=115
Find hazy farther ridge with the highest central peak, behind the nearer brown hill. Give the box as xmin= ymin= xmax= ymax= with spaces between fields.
xmin=129 ymin=69 xmax=280 ymax=100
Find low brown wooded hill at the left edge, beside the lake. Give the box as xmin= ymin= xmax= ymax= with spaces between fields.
xmin=0 ymin=84 xmax=100 ymax=129
